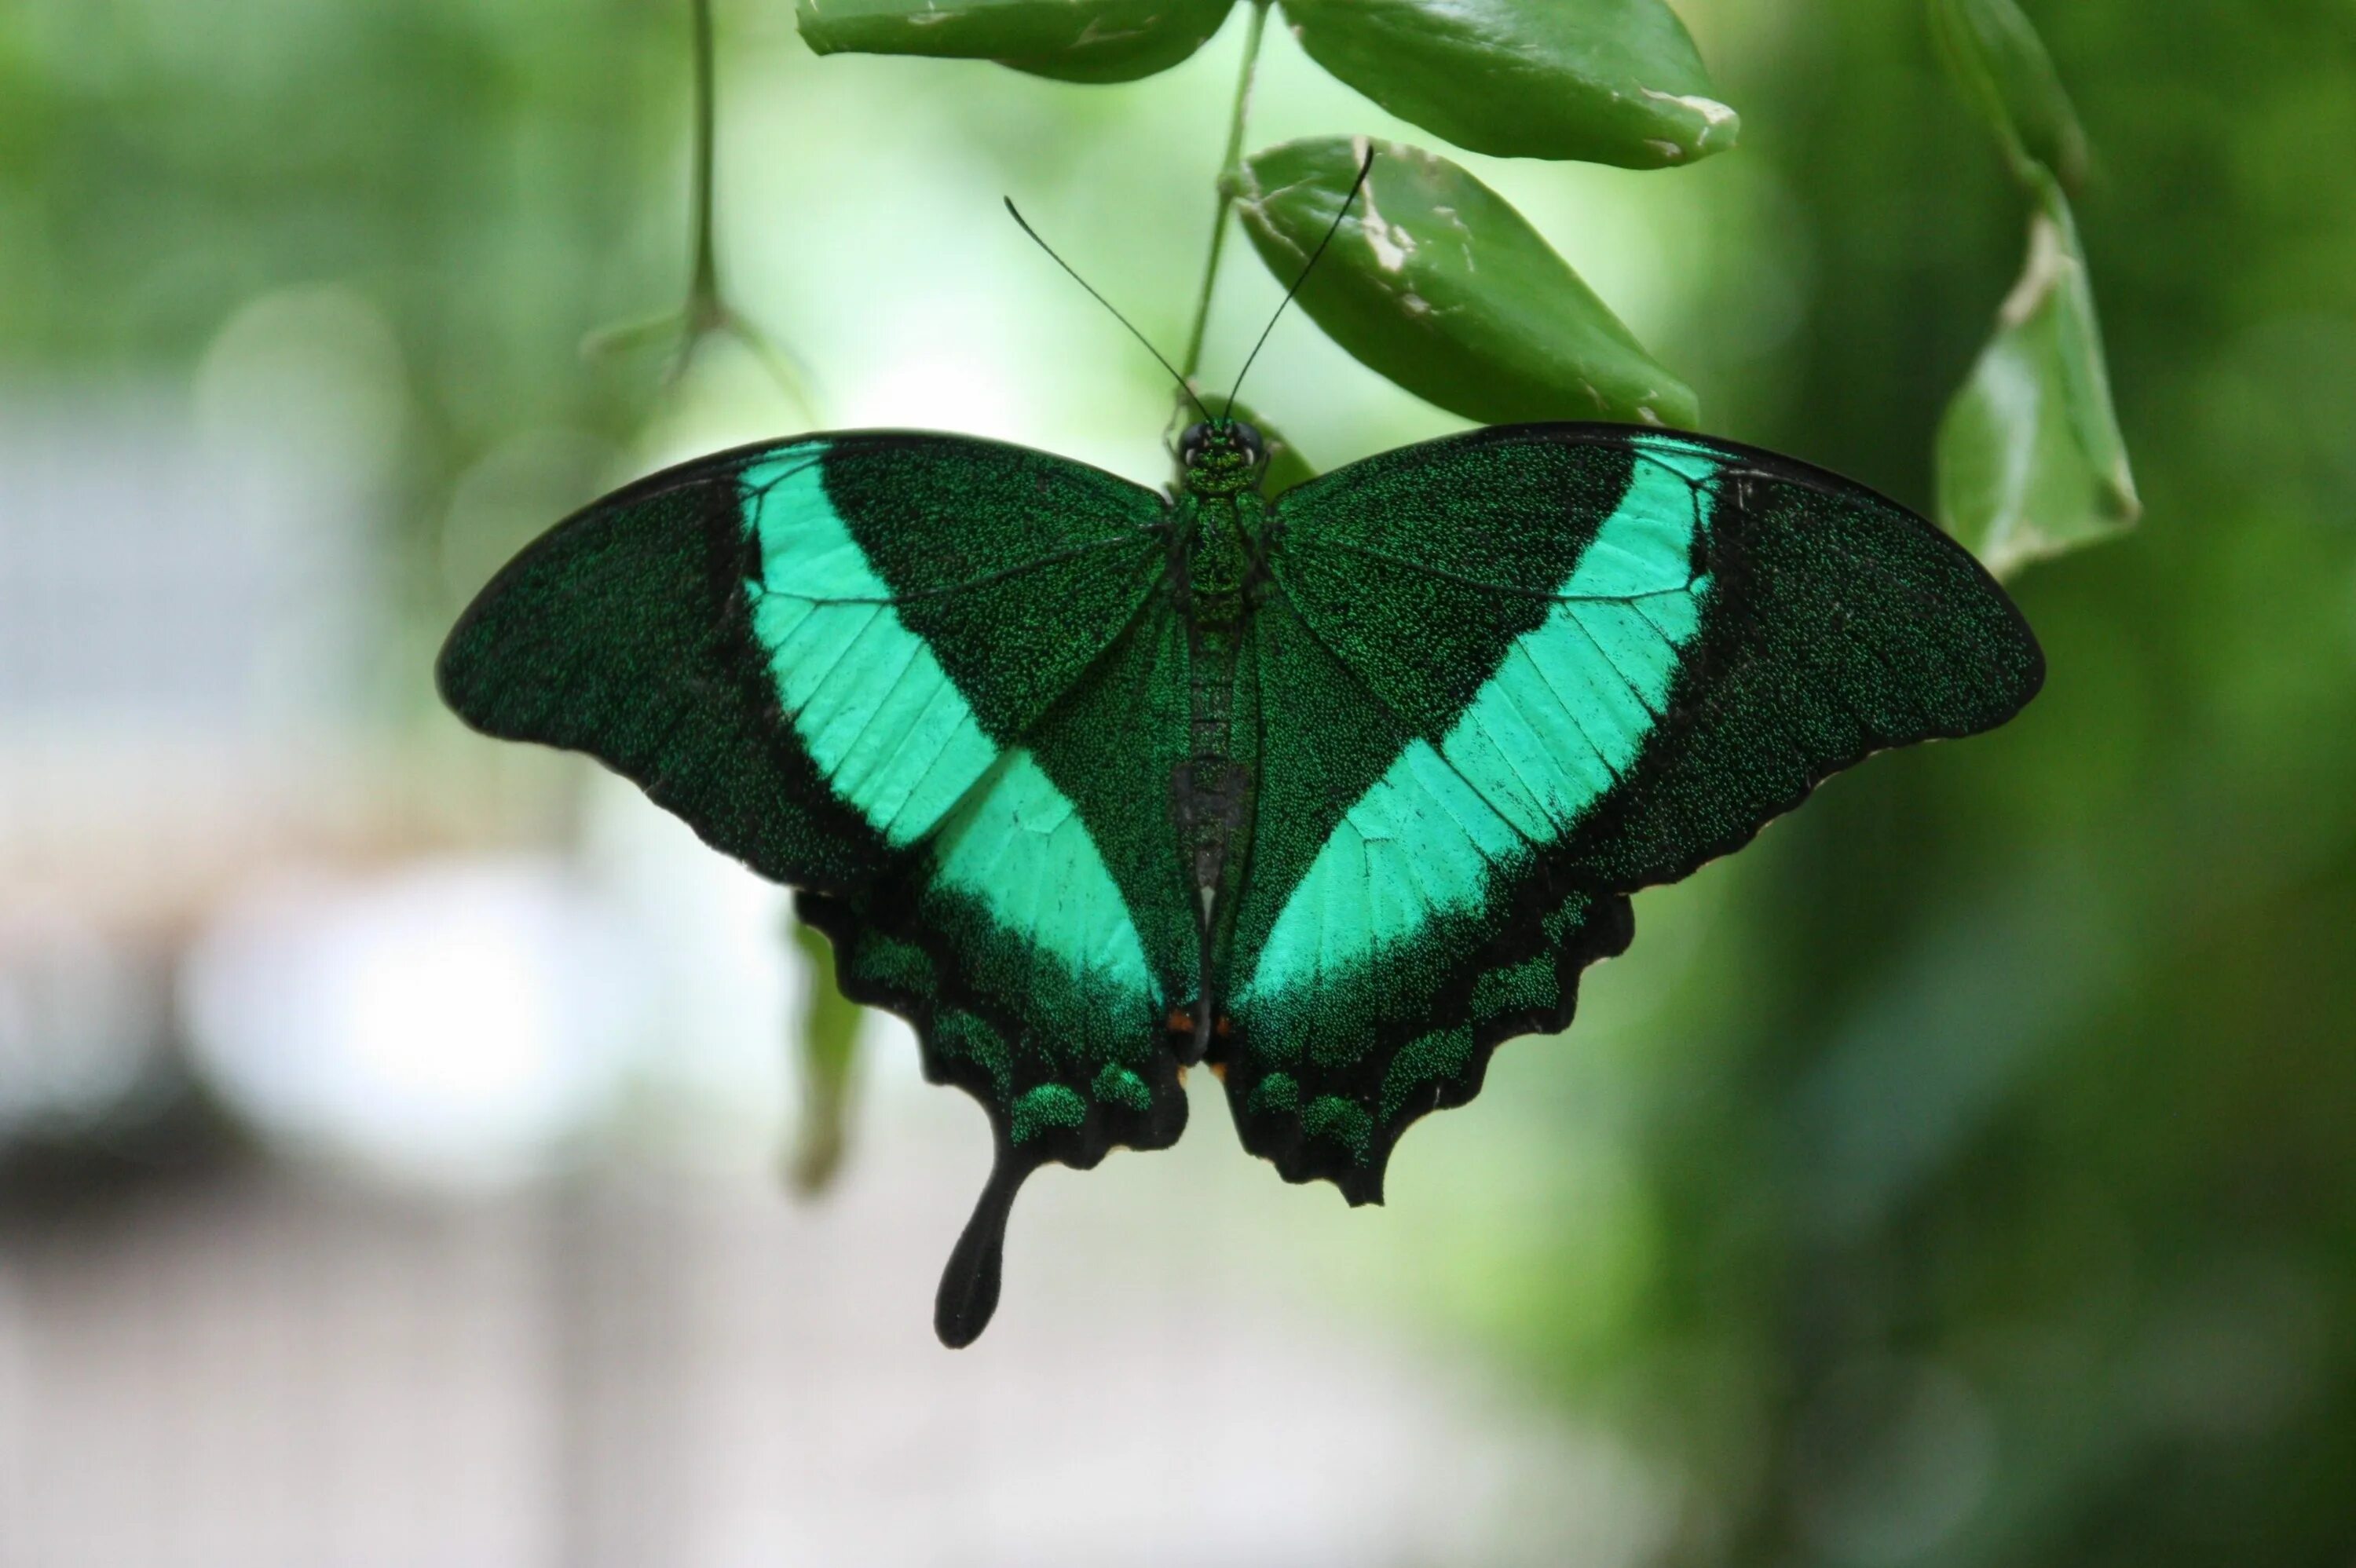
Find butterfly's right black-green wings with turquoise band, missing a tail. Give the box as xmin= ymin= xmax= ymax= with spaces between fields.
xmin=1223 ymin=426 xmax=2043 ymax=1201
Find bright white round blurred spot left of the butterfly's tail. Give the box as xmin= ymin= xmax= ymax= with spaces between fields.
xmin=181 ymin=859 xmax=643 ymax=1182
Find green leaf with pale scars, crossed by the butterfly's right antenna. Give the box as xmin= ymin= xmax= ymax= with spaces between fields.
xmin=1235 ymin=137 xmax=1696 ymax=426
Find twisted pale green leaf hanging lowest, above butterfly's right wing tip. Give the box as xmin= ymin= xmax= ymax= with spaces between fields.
xmin=1939 ymin=165 xmax=2142 ymax=577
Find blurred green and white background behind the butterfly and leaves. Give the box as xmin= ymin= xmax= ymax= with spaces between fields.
xmin=0 ymin=0 xmax=2356 ymax=1568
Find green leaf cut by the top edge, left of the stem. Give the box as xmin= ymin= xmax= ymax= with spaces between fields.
xmin=794 ymin=0 xmax=1235 ymax=82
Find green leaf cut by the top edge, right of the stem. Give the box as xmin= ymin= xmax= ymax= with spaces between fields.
xmin=1284 ymin=0 xmax=1741 ymax=170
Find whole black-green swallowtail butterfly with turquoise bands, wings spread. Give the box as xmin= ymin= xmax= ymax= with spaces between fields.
xmin=441 ymin=424 xmax=2043 ymax=1344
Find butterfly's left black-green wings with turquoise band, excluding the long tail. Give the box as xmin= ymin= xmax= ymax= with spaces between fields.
xmin=438 ymin=433 xmax=1192 ymax=1196
